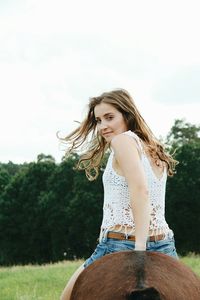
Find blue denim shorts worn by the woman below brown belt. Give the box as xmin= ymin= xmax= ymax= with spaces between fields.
xmin=84 ymin=231 xmax=178 ymax=268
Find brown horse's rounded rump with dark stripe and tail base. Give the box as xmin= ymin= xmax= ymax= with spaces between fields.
xmin=71 ymin=251 xmax=200 ymax=300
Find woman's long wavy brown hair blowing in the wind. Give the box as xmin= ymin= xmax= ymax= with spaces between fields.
xmin=57 ymin=89 xmax=178 ymax=181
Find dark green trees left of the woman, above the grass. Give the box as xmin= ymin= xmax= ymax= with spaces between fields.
xmin=0 ymin=154 xmax=103 ymax=265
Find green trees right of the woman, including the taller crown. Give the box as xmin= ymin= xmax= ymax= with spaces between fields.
xmin=166 ymin=120 xmax=200 ymax=254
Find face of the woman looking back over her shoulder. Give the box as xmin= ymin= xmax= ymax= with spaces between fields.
xmin=94 ymin=103 xmax=128 ymax=142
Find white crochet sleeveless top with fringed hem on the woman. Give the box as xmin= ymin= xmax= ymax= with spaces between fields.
xmin=99 ymin=130 xmax=170 ymax=240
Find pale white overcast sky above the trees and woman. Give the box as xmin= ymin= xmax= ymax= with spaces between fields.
xmin=0 ymin=0 xmax=200 ymax=163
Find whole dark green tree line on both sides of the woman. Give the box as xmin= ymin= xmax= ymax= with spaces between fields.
xmin=0 ymin=120 xmax=200 ymax=265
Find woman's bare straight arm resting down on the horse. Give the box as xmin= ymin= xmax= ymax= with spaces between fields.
xmin=111 ymin=134 xmax=150 ymax=250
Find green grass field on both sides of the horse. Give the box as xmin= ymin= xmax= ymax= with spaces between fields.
xmin=0 ymin=255 xmax=200 ymax=300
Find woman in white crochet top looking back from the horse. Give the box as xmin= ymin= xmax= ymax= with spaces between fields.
xmin=61 ymin=90 xmax=178 ymax=300
